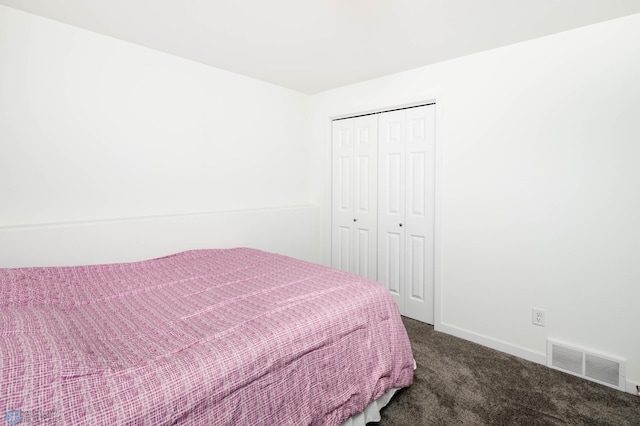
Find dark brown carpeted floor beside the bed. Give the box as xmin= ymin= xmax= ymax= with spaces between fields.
xmin=377 ymin=318 xmax=640 ymax=426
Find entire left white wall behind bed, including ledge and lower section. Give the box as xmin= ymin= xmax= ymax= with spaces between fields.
xmin=0 ymin=6 xmax=319 ymax=267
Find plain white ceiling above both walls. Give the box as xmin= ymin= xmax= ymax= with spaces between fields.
xmin=0 ymin=0 xmax=640 ymax=94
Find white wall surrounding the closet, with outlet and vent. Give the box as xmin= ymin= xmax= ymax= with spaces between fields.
xmin=311 ymin=15 xmax=640 ymax=387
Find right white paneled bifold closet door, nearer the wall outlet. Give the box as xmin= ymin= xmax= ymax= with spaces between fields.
xmin=378 ymin=105 xmax=435 ymax=324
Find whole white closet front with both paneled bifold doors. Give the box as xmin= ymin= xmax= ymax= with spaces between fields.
xmin=331 ymin=104 xmax=436 ymax=324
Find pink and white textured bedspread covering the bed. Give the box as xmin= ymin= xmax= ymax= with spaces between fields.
xmin=0 ymin=248 xmax=413 ymax=425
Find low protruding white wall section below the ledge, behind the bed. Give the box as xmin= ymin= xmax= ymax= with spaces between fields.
xmin=0 ymin=206 xmax=319 ymax=268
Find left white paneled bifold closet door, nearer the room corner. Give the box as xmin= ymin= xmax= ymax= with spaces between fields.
xmin=331 ymin=115 xmax=378 ymax=280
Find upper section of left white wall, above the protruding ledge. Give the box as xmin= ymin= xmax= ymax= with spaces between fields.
xmin=0 ymin=6 xmax=315 ymax=226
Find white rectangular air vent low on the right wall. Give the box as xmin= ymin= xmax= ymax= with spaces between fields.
xmin=547 ymin=339 xmax=626 ymax=391
